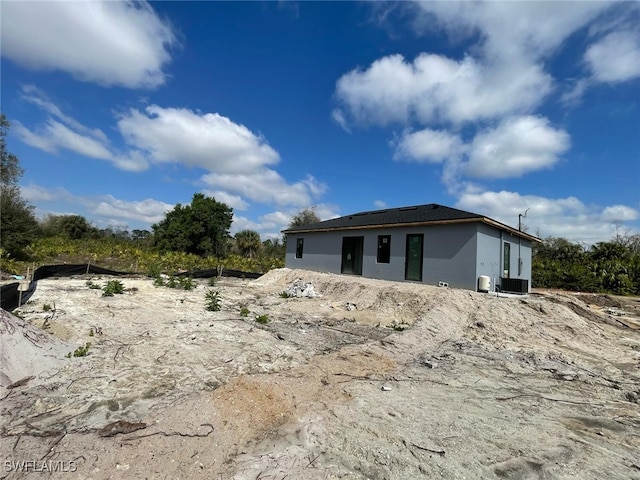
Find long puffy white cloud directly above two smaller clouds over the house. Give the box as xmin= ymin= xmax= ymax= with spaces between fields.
xmin=333 ymin=53 xmax=552 ymax=126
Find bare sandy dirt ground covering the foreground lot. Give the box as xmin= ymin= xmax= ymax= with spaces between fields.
xmin=0 ymin=269 xmax=640 ymax=480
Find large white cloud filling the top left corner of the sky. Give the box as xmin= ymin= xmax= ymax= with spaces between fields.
xmin=1 ymin=1 xmax=177 ymax=88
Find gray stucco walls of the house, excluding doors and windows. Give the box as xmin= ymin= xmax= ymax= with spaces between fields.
xmin=285 ymin=222 xmax=531 ymax=290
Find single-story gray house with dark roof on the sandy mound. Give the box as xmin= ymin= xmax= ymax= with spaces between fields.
xmin=282 ymin=203 xmax=540 ymax=293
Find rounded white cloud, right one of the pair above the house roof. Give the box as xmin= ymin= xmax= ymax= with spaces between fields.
xmin=464 ymin=116 xmax=570 ymax=178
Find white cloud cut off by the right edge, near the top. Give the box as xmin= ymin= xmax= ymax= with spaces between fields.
xmin=584 ymin=29 xmax=640 ymax=83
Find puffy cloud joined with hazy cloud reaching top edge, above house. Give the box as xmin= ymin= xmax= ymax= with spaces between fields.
xmin=332 ymin=1 xmax=610 ymax=127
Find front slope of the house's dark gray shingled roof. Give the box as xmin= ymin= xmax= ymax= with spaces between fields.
xmin=284 ymin=203 xmax=484 ymax=232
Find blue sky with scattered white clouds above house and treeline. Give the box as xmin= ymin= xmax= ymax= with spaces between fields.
xmin=1 ymin=1 xmax=640 ymax=245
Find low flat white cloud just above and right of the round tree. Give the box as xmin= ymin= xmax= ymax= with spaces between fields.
xmin=202 ymin=172 xmax=326 ymax=207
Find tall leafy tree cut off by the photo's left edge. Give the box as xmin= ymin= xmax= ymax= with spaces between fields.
xmin=0 ymin=114 xmax=38 ymax=258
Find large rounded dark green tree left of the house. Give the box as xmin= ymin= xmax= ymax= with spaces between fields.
xmin=151 ymin=193 xmax=233 ymax=256
